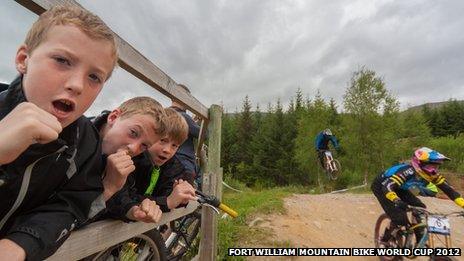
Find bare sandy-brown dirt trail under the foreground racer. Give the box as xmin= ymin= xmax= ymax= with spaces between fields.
xmin=249 ymin=194 xmax=464 ymax=260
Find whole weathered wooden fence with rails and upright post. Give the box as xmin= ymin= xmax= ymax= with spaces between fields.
xmin=15 ymin=0 xmax=222 ymax=261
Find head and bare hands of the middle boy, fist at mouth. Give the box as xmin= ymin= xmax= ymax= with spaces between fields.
xmin=93 ymin=97 xmax=167 ymax=222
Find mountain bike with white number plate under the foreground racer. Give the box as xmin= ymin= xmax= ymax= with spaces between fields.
xmin=374 ymin=206 xmax=464 ymax=260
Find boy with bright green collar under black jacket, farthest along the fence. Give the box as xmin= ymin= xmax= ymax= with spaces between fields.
xmin=107 ymin=108 xmax=195 ymax=221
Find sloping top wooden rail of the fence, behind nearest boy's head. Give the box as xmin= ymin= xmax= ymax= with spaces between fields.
xmin=15 ymin=0 xmax=208 ymax=119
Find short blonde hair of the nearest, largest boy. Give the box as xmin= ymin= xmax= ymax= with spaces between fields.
xmin=24 ymin=5 xmax=118 ymax=75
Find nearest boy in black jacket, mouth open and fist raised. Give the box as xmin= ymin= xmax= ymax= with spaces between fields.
xmin=0 ymin=6 xmax=117 ymax=260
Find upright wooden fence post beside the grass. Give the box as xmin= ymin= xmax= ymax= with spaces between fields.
xmin=199 ymin=104 xmax=222 ymax=261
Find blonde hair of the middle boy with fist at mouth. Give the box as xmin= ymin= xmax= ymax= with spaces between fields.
xmin=118 ymin=96 xmax=169 ymax=137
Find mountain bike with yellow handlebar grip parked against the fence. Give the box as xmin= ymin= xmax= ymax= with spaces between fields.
xmin=86 ymin=190 xmax=238 ymax=261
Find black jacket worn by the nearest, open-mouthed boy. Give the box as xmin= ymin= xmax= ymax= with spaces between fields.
xmin=0 ymin=77 xmax=103 ymax=260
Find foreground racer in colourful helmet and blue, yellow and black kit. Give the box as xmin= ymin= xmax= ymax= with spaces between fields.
xmin=371 ymin=147 xmax=464 ymax=242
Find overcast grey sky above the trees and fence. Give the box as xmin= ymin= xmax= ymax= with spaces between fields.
xmin=0 ymin=0 xmax=464 ymax=114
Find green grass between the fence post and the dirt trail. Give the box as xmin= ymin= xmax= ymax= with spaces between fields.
xmin=218 ymin=186 xmax=310 ymax=260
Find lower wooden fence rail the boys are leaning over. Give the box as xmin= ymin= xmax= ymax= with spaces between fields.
xmin=47 ymin=201 xmax=199 ymax=260
